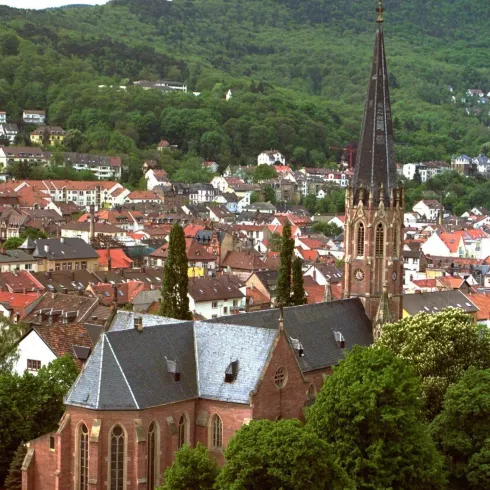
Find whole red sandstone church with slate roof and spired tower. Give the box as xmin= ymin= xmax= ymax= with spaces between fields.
xmin=22 ymin=3 xmax=404 ymax=490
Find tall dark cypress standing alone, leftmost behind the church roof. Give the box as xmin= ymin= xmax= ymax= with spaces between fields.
xmin=160 ymin=224 xmax=192 ymax=320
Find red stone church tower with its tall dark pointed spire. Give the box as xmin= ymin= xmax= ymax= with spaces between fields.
xmin=344 ymin=0 xmax=404 ymax=338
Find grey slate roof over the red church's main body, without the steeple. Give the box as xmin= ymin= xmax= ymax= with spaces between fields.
xmin=65 ymin=299 xmax=373 ymax=410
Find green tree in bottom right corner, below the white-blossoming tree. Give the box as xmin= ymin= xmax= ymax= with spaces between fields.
xmin=430 ymin=367 xmax=490 ymax=490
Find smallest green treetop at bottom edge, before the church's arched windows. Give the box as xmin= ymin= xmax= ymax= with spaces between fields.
xmin=160 ymin=442 xmax=218 ymax=490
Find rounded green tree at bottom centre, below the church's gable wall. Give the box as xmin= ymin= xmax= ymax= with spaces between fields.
xmin=216 ymin=420 xmax=353 ymax=490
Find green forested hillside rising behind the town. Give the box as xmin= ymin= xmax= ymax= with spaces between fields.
xmin=0 ymin=0 xmax=490 ymax=177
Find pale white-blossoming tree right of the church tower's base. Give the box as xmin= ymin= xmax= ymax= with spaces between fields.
xmin=377 ymin=308 xmax=490 ymax=419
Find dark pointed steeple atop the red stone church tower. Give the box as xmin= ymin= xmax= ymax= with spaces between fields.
xmin=353 ymin=0 xmax=398 ymax=204
